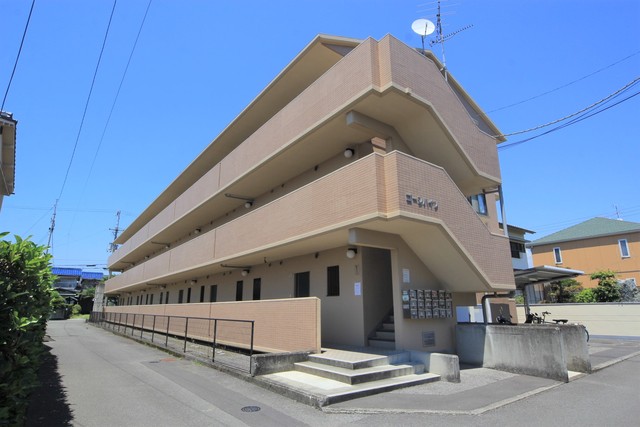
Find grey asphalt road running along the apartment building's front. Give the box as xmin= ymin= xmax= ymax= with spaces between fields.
xmin=27 ymin=320 xmax=640 ymax=427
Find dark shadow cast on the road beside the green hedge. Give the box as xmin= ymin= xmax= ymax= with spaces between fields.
xmin=26 ymin=346 xmax=73 ymax=427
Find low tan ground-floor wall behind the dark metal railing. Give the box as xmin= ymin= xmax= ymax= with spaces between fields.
xmin=105 ymin=298 xmax=320 ymax=353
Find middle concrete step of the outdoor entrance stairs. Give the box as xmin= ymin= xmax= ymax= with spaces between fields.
xmin=294 ymin=362 xmax=424 ymax=385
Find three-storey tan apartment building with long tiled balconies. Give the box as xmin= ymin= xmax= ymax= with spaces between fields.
xmin=105 ymin=36 xmax=515 ymax=352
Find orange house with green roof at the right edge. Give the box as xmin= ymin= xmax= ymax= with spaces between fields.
xmin=527 ymin=218 xmax=640 ymax=288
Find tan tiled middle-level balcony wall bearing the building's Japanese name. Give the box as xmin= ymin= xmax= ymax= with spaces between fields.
xmin=107 ymin=152 xmax=513 ymax=292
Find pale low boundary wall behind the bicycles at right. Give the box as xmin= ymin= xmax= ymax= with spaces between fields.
xmin=517 ymin=303 xmax=640 ymax=337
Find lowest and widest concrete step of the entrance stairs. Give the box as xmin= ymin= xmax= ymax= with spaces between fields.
xmin=260 ymin=371 xmax=440 ymax=407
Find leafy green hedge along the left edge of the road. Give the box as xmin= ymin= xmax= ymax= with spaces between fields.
xmin=0 ymin=233 xmax=53 ymax=425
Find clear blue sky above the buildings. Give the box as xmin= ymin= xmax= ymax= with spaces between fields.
xmin=0 ymin=0 xmax=640 ymax=266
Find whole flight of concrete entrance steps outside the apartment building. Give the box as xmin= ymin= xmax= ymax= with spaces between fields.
xmin=255 ymin=349 xmax=440 ymax=406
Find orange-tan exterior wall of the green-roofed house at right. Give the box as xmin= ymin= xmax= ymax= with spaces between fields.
xmin=531 ymin=232 xmax=640 ymax=288
